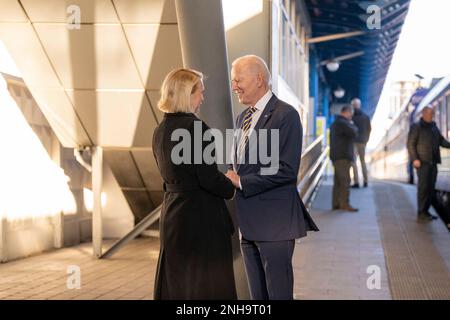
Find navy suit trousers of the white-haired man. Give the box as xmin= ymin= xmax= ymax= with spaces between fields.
xmin=241 ymin=238 xmax=295 ymax=300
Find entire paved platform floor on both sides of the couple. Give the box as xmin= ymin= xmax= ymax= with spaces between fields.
xmin=0 ymin=178 xmax=450 ymax=300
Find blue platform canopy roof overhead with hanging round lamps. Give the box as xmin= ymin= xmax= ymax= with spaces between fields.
xmin=305 ymin=0 xmax=410 ymax=116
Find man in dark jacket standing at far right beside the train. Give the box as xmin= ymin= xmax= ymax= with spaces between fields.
xmin=407 ymin=107 xmax=450 ymax=220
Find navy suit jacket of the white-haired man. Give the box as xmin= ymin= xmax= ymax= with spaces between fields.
xmin=235 ymin=95 xmax=319 ymax=241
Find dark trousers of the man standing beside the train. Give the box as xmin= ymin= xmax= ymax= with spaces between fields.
xmin=417 ymin=162 xmax=437 ymax=213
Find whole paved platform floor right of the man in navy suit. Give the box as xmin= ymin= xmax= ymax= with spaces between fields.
xmin=294 ymin=178 xmax=450 ymax=300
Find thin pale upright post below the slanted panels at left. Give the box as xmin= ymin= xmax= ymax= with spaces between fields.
xmin=92 ymin=147 xmax=103 ymax=258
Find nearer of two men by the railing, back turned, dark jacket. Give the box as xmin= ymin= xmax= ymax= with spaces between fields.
xmin=330 ymin=105 xmax=358 ymax=212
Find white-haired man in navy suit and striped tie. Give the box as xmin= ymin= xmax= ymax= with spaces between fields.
xmin=227 ymin=56 xmax=318 ymax=300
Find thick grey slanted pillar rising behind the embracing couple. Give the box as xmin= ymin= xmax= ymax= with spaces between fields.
xmin=175 ymin=0 xmax=250 ymax=299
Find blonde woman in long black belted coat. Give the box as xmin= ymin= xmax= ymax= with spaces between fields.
xmin=153 ymin=69 xmax=236 ymax=300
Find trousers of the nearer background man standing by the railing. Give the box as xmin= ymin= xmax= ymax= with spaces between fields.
xmin=333 ymin=159 xmax=352 ymax=208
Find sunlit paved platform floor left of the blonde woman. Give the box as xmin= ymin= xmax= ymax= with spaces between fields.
xmin=0 ymin=238 xmax=159 ymax=300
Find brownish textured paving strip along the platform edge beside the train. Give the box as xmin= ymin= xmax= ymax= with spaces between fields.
xmin=374 ymin=184 xmax=450 ymax=300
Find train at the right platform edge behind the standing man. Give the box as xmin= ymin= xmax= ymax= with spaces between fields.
xmin=369 ymin=75 xmax=450 ymax=228
